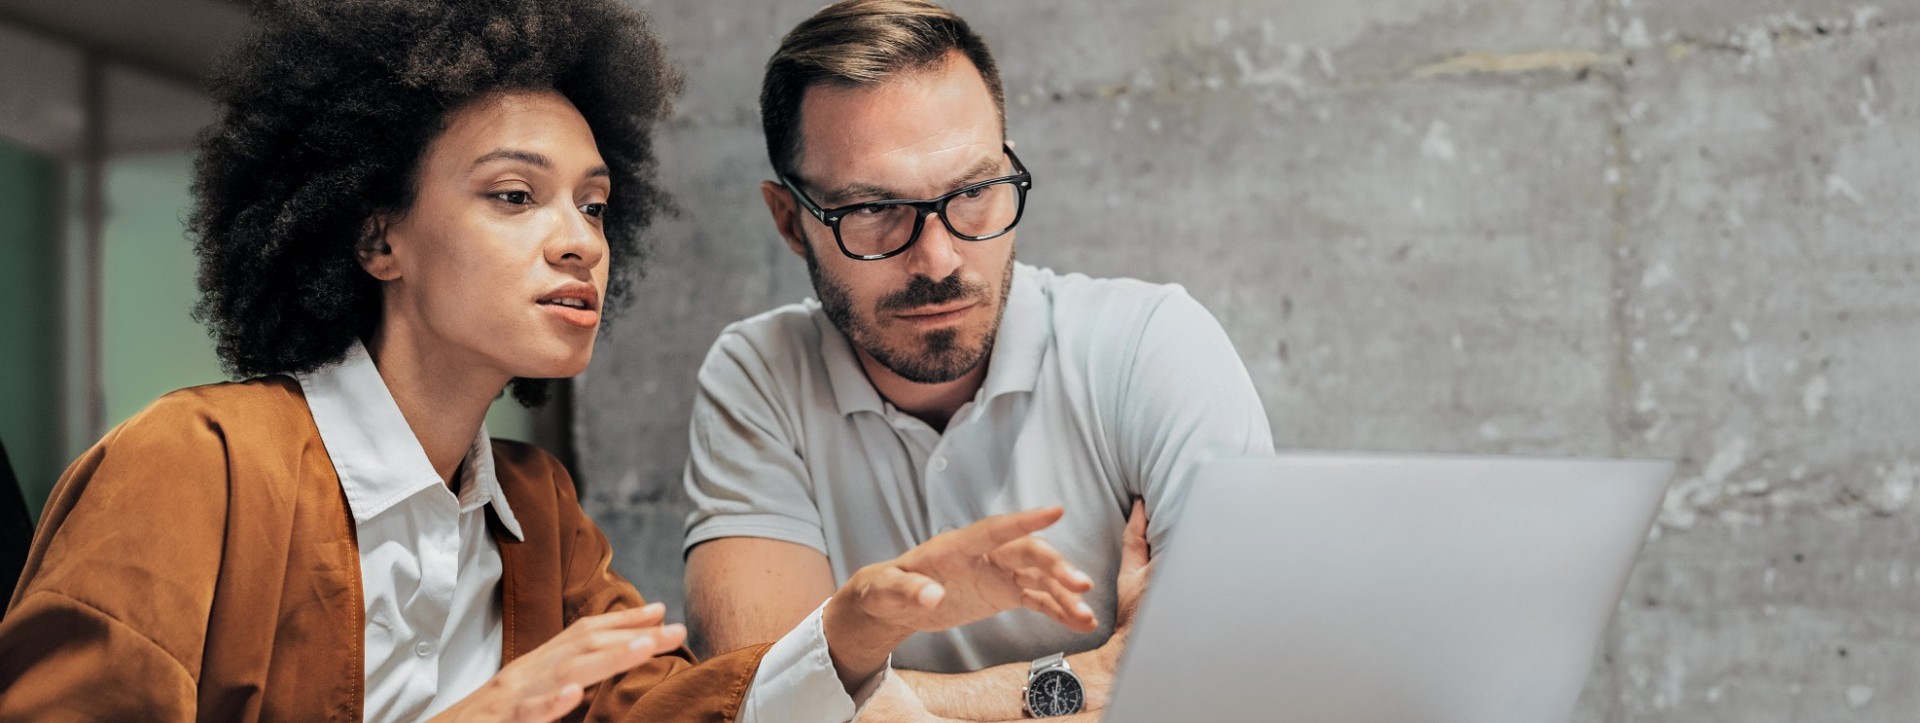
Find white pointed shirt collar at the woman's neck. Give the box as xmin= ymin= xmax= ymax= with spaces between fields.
xmin=294 ymin=339 xmax=524 ymax=539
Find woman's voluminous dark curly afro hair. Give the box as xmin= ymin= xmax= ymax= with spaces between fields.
xmin=188 ymin=0 xmax=680 ymax=405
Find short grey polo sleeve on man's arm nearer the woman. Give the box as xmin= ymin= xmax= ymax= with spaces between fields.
xmin=682 ymin=330 xmax=828 ymax=554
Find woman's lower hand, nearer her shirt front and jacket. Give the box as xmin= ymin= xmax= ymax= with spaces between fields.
xmin=434 ymin=602 xmax=687 ymax=723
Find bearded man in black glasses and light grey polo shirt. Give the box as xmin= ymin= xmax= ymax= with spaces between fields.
xmin=685 ymin=0 xmax=1273 ymax=719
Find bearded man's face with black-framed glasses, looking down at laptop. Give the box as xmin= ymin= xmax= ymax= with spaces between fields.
xmin=766 ymin=52 xmax=1014 ymax=384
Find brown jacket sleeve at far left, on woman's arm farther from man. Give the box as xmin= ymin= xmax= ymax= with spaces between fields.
xmin=0 ymin=399 xmax=227 ymax=721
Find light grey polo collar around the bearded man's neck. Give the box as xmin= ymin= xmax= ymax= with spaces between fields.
xmin=810 ymin=263 xmax=1054 ymax=414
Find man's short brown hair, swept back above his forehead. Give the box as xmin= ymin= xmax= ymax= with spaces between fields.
xmin=760 ymin=0 xmax=1006 ymax=175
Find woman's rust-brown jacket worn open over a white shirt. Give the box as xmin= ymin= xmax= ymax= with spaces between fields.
xmin=0 ymin=378 xmax=766 ymax=721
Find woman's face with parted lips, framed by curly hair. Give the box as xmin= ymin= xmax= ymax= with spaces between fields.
xmin=363 ymin=90 xmax=612 ymax=384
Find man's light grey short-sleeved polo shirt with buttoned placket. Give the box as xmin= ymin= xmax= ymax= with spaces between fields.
xmin=685 ymin=265 xmax=1273 ymax=673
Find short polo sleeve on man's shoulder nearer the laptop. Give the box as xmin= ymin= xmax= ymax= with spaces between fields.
xmin=1114 ymin=286 xmax=1273 ymax=556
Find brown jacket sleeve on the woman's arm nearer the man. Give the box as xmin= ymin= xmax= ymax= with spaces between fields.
xmin=551 ymin=452 xmax=768 ymax=723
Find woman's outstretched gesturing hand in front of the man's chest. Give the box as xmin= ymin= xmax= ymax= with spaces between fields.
xmin=824 ymin=506 xmax=1098 ymax=690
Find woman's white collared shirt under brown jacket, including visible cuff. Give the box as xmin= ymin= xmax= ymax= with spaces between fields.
xmin=296 ymin=341 xmax=887 ymax=723
